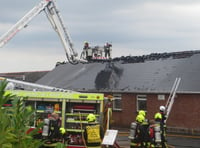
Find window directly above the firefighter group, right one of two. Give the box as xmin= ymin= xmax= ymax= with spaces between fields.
xmin=137 ymin=95 xmax=147 ymax=111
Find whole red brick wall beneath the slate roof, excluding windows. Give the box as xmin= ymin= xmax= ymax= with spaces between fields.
xmin=113 ymin=94 xmax=200 ymax=129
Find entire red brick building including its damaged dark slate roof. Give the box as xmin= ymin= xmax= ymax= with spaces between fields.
xmin=34 ymin=51 xmax=200 ymax=132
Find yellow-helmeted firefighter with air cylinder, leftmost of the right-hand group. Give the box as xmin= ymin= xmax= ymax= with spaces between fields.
xmin=129 ymin=114 xmax=145 ymax=148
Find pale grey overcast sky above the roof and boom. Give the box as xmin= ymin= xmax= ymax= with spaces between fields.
xmin=0 ymin=0 xmax=200 ymax=73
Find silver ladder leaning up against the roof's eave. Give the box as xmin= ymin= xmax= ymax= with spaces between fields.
xmin=165 ymin=78 xmax=181 ymax=121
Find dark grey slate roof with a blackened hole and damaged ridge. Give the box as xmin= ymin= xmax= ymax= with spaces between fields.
xmin=36 ymin=51 xmax=200 ymax=93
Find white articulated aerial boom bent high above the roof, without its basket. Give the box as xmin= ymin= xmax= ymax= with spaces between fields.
xmin=0 ymin=0 xmax=80 ymax=64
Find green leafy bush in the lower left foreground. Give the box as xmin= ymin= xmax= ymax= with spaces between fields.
xmin=0 ymin=81 xmax=42 ymax=148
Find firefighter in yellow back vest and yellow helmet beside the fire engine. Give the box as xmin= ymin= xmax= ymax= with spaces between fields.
xmin=84 ymin=114 xmax=104 ymax=148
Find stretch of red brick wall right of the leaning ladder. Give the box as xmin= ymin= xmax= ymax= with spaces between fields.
xmin=167 ymin=94 xmax=200 ymax=128
